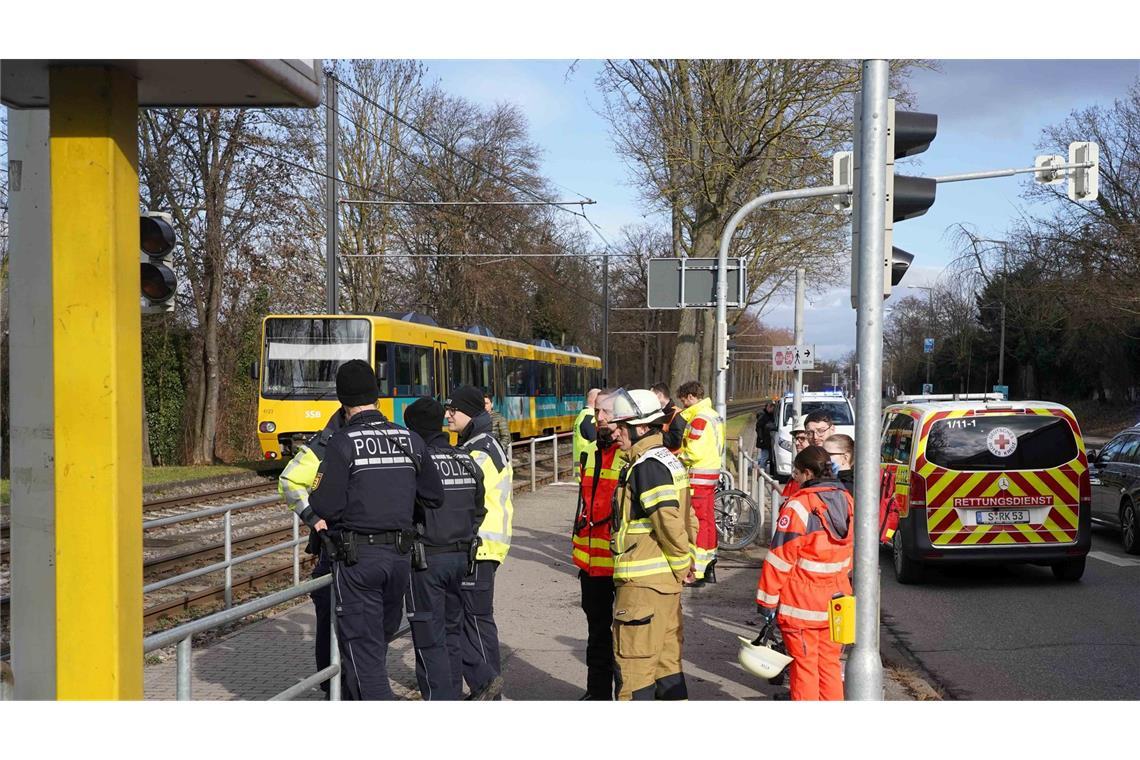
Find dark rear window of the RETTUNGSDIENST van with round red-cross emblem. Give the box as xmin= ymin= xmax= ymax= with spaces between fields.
xmin=926 ymin=415 xmax=1076 ymax=471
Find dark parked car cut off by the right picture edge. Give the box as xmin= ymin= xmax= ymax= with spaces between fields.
xmin=1089 ymin=425 xmax=1140 ymax=554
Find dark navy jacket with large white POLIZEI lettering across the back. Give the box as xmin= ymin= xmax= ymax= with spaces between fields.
xmin=309 ymin=409 xmax=443 ymax=533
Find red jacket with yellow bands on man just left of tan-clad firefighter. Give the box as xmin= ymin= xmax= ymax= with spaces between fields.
xmin=570 ymin=443 xmax=625 ymax=577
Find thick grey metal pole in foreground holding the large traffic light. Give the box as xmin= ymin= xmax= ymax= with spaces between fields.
xmin=846 ymin=60 xmax=887 ymax=700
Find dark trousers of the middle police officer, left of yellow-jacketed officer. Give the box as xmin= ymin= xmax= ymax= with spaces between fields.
xmin=404 ymin=551 xmax=467 ymax=701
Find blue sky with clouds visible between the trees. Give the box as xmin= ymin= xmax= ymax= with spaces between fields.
xmin=425 ymin=60 xmax=1140 ymax=359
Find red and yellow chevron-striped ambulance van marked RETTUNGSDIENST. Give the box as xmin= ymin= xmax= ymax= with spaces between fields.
xmin=880 ymin=393 xmax=1092 ymax=583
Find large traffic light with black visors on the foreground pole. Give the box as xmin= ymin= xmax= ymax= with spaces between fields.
xmin=852 ymin=99 xmax=938 ymax=308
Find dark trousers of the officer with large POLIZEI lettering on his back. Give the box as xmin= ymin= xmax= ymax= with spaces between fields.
xmin=333 ymin=545 xmax=412 ymax=700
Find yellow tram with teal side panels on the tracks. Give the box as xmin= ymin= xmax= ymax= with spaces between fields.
xmin=257 ymin=313 xmax=602 ymax=459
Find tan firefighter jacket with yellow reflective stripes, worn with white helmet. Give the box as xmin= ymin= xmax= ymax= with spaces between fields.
xmin=610 ymin=433 xmax=697 ymax=594
